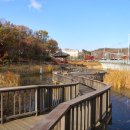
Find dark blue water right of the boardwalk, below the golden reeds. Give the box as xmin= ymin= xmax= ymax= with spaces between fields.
xmin=107 ymin=90 xmax=130 ymax=130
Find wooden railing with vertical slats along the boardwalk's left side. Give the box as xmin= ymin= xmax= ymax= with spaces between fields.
xmin=0 ymin=75 xmax=79 ymax=123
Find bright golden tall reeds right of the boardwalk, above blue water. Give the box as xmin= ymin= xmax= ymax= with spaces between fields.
xmin=104 ymin=70 xmax=130 ymax=89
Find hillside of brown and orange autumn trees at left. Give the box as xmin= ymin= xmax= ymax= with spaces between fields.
xmin=0 ymin=20 xmax=58 ymax=63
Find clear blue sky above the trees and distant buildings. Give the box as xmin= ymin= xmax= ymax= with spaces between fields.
xmin=0 ymin=0 xmax=130 ymax=50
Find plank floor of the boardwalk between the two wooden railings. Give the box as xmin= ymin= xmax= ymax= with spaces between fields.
xmin=0 ymin=84 xmax=94 ymax=130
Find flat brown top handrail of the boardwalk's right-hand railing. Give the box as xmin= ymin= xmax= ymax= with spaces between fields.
xmin=31 ymin=87 xmax=110 ymax=130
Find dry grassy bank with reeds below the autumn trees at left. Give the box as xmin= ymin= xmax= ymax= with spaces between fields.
xmin=0 ymin=65 xmax=57 ymax=87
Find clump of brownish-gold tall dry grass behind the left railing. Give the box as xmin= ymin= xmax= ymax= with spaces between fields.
xmin=0 ymin=71 xmax=20 ymax=87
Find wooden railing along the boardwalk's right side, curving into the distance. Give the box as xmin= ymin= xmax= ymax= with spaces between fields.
xmin=31 ymin=73 xmax=111 ymax=130
